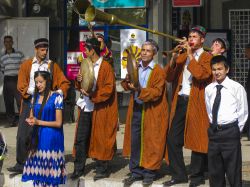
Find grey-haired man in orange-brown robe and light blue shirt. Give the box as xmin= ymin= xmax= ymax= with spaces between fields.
xmin=122 ymin=39 xmax=168 ymax=186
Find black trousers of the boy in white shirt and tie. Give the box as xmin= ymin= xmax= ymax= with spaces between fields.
xmin=208 ymin=123 xmax=242 ymax=187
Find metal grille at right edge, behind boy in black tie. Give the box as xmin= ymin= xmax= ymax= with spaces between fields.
xmin=229 ymin=9 xmax=250 ymax=85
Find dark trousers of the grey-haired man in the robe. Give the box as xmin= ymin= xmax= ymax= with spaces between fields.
xmin=129 ymin=103 xmax=156 ymax=179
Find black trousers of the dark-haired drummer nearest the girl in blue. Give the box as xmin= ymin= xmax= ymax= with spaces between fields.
xmin=74 ymin=110 xmax=92 ymax=171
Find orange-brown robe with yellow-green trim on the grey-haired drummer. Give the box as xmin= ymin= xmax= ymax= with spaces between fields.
xmin=122 ymin=65 xmax=168 ymax=170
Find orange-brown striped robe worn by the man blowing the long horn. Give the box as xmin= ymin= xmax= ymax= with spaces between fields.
xmin=165 ymin=51 xmax=212 ymax=153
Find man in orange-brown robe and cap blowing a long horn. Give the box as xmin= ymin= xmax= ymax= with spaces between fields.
xmin=164 ymin=26 xmax=212 ymax=187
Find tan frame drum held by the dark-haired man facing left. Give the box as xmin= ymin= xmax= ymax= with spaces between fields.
xmin=80 ymin=58 xmax=95 ymax=93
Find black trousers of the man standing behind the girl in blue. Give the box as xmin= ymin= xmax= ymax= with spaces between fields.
xmin=16 ymin=99 xmax=33 ymax=166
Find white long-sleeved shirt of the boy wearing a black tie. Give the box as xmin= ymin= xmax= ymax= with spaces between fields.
xmin=205 ymin=77 xmax=248 ymax=131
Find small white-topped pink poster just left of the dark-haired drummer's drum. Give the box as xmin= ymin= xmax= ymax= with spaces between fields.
xmin=67 ymin=51 xmax=81 ymax=80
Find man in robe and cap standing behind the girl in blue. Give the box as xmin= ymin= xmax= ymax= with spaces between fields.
xmin=8 ymin=38 xmax=70 ymax=173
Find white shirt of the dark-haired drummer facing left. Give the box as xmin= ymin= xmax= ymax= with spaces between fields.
xmin=76 ymin=57 xmax=103 ymax=112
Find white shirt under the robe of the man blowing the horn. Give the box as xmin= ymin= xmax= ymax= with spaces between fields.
xmin=178 ymin=48 xmax=204 ymax=95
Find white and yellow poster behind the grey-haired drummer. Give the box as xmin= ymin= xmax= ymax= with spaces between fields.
xmin=120 ymin=29 xmax=147 ymax=79
